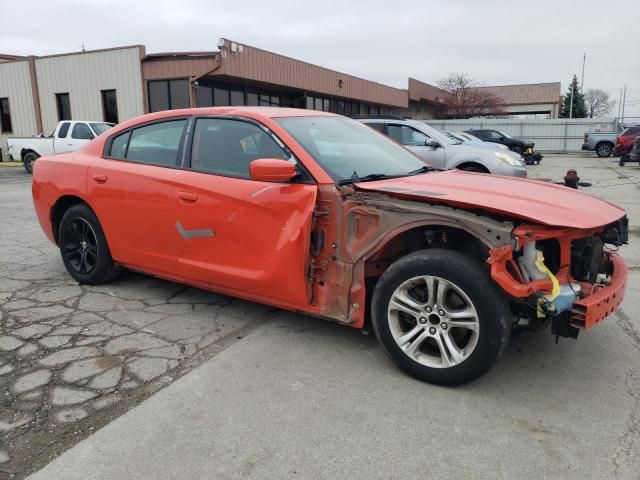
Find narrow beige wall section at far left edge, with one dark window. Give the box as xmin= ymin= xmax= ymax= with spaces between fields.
xmin=0 ymin=60 xmax=37 ymax=159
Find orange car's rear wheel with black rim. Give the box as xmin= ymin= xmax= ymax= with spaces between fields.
xmin=58 ymin=203 xmax=118 ymax=285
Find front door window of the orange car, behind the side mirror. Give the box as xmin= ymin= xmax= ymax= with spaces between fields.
xmin=190 ymin=118 xmax=290 ymax=179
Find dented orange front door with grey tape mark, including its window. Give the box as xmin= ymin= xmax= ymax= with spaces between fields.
xmin=175 ymin=117 xmax=317 ymax=305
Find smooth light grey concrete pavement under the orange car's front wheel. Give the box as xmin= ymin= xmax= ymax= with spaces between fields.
xmin=0 ymin=156 xmax=640 ymax=480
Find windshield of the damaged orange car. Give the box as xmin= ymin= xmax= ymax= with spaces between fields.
xmin=275 ymin=117 xmax=426 ymax=182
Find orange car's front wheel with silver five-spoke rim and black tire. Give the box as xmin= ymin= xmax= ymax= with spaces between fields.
xmin=371 ymin=248 xmax=511 ymax=386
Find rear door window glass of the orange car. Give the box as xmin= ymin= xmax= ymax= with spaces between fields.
xmin=108 ymin=119 xmax=186 ymax=167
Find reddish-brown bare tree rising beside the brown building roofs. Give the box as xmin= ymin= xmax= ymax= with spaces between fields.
xmin=437 ymin=73 xmax=505 ymax=118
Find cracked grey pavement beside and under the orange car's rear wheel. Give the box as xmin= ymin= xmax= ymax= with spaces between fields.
xmin=0 ymin=169 xmax=270 ymax=478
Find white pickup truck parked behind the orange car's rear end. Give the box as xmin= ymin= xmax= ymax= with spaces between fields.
xmin=7 ymin=120 xmax=114 ymax=173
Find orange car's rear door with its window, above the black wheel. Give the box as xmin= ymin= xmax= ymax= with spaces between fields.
xmin=87 ymin=118 xmax=187 ymax=277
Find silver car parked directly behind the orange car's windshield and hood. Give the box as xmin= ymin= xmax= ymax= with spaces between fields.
xmin=358 ymin=117 xmax=527 ymax=177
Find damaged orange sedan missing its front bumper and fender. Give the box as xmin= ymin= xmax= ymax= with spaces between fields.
xmin=33 ymin=107 xmax=628 ymax=385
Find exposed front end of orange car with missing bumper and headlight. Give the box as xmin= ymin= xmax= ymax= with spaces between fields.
xmin=487 ymin=216 xmax=628 ymax=338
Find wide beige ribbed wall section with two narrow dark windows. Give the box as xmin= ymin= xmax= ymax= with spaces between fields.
xmin=35 ymin=47 xmax=144 ymax=134
